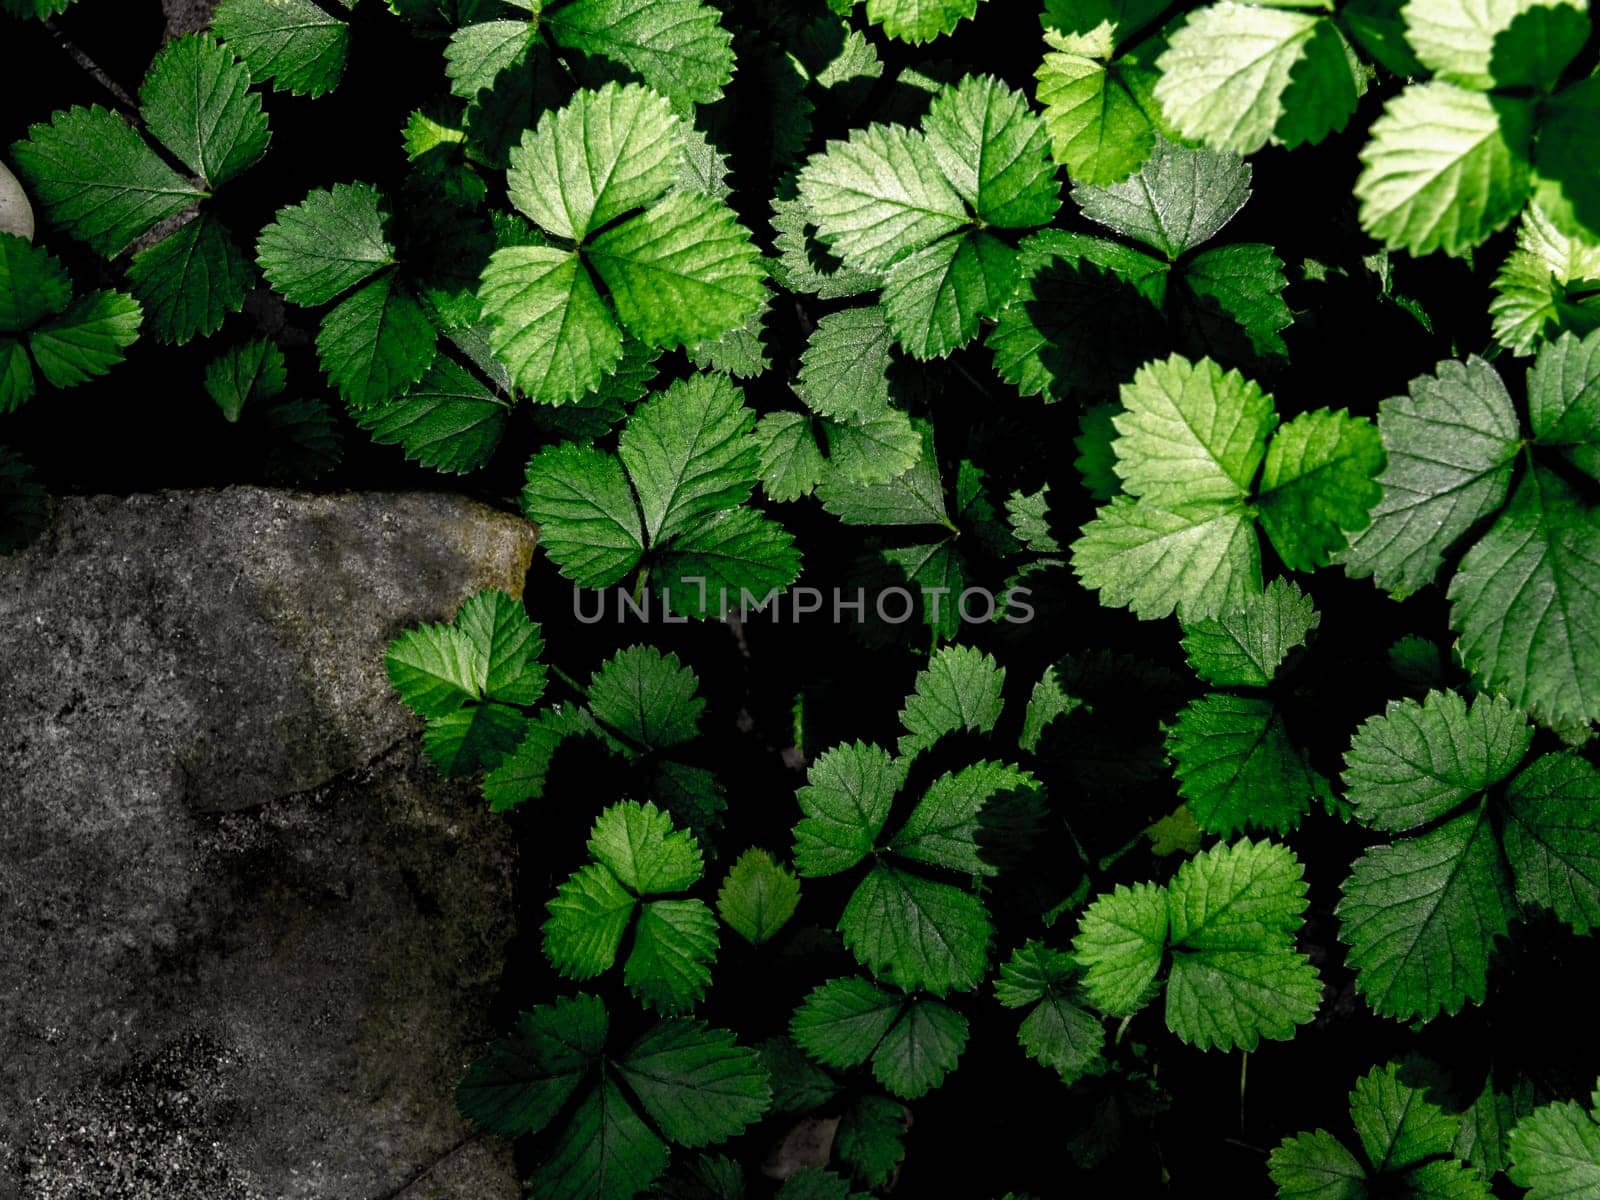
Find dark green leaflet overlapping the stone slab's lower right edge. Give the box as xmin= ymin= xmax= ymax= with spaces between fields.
xmin=456 ymin=995 xmax=606 ymax=1136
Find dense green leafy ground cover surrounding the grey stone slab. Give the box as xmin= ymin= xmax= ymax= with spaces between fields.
xmin=0 ymin=0 xmax=1600 ymax=1200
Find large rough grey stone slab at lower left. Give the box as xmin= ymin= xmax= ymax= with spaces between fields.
xmin=0 ymin=488 xmax=533 ymax=1200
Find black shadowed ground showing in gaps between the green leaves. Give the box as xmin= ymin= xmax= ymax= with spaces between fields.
xmin=0 ymin=0 xmax=1600 ymax=1197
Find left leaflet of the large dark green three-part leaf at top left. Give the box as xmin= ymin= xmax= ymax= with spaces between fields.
xmin=11 ymin=106 xmax=203 ymax=258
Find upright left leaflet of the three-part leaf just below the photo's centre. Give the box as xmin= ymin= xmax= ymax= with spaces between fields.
xmin=795 ymin=742 xmax=904 ymax=877
